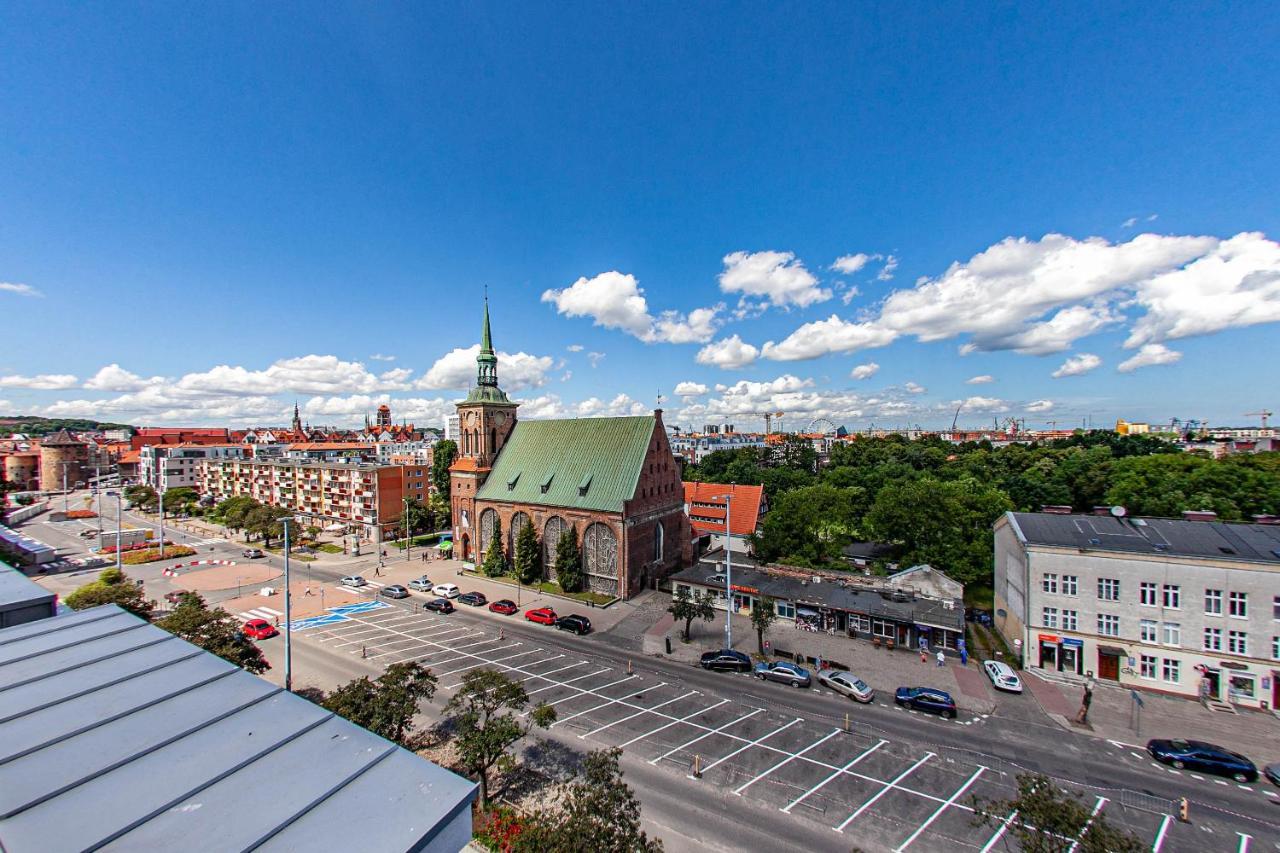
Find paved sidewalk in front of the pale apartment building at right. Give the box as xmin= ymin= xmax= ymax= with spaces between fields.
xmin=1021 ymin=667 xmax=1280 ymax=767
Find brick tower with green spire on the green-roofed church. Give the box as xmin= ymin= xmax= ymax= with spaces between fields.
xmin=449 ymin=296 xmax=520 ymax=560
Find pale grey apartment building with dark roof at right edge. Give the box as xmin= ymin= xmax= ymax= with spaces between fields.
xmin=995 ymin=507 xmax=1280 ymax=710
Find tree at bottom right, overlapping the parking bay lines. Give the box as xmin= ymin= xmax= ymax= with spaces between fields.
xmin=973 ymin=774 xmax=1147 ymax=853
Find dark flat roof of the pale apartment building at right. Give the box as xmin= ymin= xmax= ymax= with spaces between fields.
xmin=1007 ymin=512 xmax=1280 ymax=565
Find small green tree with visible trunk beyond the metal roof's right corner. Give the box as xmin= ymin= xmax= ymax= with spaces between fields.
xmin=444 ymin=669 xmax=556 ymax=808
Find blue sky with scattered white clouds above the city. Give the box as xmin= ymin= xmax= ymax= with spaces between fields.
xmin=0 ymin=4 xmax=1280 ymax=429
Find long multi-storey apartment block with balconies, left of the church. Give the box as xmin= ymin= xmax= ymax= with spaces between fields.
xmin=197 ymin=459 xmax=430 ymax=543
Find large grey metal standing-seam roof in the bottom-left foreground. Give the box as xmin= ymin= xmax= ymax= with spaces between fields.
xmin=0 ymin=606 xmax=476 ymax=853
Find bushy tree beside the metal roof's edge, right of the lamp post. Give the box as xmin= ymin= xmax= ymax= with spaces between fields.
xmin=320 ymin=661 xmax=436 ymax=748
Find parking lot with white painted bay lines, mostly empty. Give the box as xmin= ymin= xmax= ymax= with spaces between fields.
xmin=285 ymin=584 xmax=1254 ymax=850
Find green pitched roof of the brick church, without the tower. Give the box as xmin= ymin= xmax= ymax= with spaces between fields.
xmin=476 ymin=415 xmax=657 ymax=512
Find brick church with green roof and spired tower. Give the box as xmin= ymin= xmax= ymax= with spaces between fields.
xmin=449 ymin=300 xmax=691 ymax=598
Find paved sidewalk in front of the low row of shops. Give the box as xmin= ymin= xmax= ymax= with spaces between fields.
xmin=624 ymin=596 xmax=996 ymax=713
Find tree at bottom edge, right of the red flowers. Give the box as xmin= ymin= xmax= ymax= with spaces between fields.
xmin=544 ymin=747 xmax=662 ymax=853
